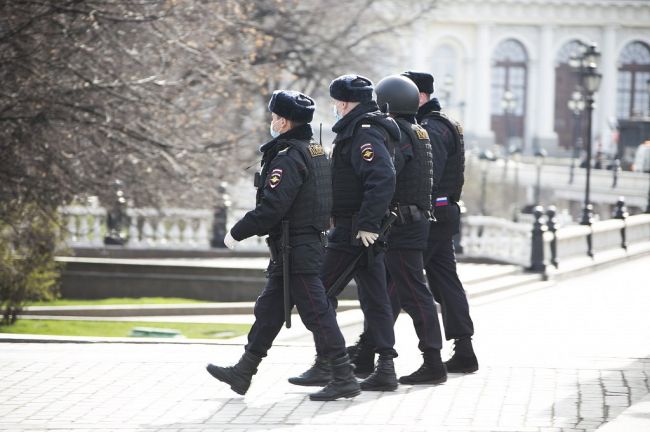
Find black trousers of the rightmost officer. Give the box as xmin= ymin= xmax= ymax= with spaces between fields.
xmin=424 ymin=230 xmax=474 ymax=340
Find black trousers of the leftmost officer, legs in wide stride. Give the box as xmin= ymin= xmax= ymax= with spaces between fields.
xmin=246 ymin=274 xmax=345 ymax=359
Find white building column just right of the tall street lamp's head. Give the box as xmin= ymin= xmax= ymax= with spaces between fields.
xmin=593 ymin=25 xmax=618 ymax=154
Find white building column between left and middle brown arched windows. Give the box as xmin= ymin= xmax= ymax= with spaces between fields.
xmin=530 ymin=25 xmax=559 ymax=154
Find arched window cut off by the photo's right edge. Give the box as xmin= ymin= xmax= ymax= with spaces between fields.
xmin=616 ymin=41 xmax=650 ymax=119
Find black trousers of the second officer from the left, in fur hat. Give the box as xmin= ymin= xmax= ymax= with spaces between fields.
xmin=316 ymin=241 xmax=397 ymax=356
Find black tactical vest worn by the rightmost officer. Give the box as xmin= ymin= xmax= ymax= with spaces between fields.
xmin=427 ymin=111 xmax=465 ymax=202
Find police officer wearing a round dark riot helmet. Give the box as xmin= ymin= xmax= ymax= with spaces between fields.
xmin=375 ymin=75 xmax=447 ymax=384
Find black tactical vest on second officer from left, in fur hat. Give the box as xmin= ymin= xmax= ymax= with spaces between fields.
xmin=332 ymin=116 xmax=396 ymax=216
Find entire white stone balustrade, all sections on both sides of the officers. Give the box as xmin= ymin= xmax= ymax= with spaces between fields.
xmin=60 ymin=206 xmax=650 ymax=268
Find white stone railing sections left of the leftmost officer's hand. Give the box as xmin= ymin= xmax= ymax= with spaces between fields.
xmin=59 ymin=206 xmax=213 ymax=249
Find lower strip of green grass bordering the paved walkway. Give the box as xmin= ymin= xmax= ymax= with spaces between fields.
xmin=0 ymin=319 xmax=250 ymax=339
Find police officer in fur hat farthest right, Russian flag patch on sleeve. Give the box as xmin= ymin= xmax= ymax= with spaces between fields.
xmin=402 ymin=71 xmax=478 ymax=373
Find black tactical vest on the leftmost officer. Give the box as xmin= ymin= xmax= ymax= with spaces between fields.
xmin=257 ymin=140 xmax=332 ymax=234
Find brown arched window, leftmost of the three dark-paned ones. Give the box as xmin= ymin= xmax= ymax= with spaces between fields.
xmin=491 ymin=39 xmax=528 ymax=149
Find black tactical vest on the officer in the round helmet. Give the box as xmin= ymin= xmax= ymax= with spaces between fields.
xmin=393 ymin=118 xmax=433 ymax=210
